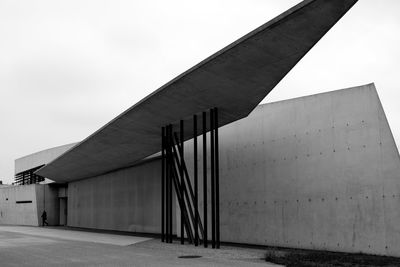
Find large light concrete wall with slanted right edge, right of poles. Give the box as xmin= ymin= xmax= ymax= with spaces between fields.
xmin=181 ymin=84 xmax=400 ymax=256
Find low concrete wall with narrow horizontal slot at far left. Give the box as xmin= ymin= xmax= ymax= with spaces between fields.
xmin=0 ymin=184 xmax=38 ymax=226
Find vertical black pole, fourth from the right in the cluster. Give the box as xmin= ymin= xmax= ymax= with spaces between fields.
xmin=193 ymin=115 xmax=199 ymax=247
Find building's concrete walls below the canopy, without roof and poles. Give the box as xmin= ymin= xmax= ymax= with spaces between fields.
xmin=0 ymin=84 xmax=400 ymax=256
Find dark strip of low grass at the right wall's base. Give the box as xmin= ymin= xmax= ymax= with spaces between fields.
xmin=265 ymin=248 xmax=400 ymax=267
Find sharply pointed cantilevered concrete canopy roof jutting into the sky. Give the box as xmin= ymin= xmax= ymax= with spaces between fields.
xmin=36 ymin=0 xmax=357 ymax=182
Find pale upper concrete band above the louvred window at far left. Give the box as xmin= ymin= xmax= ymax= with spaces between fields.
xmin=14 ymin=143 xmax=77 ymax=174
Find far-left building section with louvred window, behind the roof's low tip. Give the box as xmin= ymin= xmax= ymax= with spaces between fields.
xmin=0 ymin=143 xmax=76 ymax=226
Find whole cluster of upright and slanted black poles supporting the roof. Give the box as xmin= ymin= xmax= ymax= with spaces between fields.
xmin=161 ymin=108 xmax=220 ymax=248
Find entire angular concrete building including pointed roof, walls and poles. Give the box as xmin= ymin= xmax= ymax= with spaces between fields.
xmin=4 ymin=0 xmax=400 ymax=256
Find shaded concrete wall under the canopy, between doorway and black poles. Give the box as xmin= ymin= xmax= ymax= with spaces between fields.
xmin=68 ymin=161 xmax=169 ymax=233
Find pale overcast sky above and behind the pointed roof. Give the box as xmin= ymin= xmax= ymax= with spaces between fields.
xmin=0 ymin=0 xmax=400 ymax=183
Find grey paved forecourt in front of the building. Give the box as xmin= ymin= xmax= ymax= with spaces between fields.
xmin=0 ymin=226 xmax=277 ymax=267
